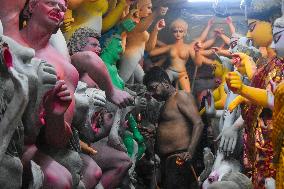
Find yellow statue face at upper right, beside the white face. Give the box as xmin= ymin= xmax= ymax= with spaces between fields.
xmin=247 ymin=20 xmax=272 ymax=47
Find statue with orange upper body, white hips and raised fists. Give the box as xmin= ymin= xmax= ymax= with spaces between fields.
xmin=119 ymin=0 xmax=167 ymax=84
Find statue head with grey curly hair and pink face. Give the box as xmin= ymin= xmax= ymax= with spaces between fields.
xmin=67 ymin=27 xmax=101 ymax=56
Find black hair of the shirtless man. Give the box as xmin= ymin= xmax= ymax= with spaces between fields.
xmin=143 ymin=66 xmax=171 ymax=86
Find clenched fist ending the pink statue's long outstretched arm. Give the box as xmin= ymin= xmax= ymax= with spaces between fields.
xmin=107 ymin=88 xmax=134 ymax=108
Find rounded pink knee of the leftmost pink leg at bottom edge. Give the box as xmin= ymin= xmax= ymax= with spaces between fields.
xmin=44 ymin=170 xmax=72 ymax=189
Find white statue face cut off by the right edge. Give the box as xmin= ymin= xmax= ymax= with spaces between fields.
xmin=271 ymin=26 xmax=284 ymax=57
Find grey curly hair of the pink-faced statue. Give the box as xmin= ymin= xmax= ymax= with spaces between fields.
xmin=67 ymin=27 xmax=100 ymax=56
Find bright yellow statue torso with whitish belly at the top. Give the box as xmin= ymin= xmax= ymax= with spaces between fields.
xmin=62 ymin=0 xmax=127 ymax=40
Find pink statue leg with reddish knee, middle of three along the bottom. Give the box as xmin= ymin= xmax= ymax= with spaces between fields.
xmin=80 ymin=154 xmax=102 ymax=189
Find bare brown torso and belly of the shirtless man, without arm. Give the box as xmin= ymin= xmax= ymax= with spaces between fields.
xmin=157 ymin=93 xmax=192 ymax=155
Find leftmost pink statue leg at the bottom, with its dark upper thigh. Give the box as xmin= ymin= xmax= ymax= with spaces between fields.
xmin=34 ymin=152 xmax=72 ymax=189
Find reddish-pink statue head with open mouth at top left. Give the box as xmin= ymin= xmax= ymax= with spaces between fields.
xmin=23 ymin=0 xmax=67 ymax=32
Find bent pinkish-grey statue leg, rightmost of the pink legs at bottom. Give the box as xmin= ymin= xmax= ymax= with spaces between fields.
xmin=93 ymin=141 xmax=132 ymax=189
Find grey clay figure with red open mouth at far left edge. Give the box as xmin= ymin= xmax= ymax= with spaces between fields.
xmin=0 ymin=37 xmax=29 ymax=189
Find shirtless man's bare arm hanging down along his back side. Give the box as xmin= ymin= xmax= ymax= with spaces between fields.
xmin=178 ymin=93 xmax=203 ymax=155
